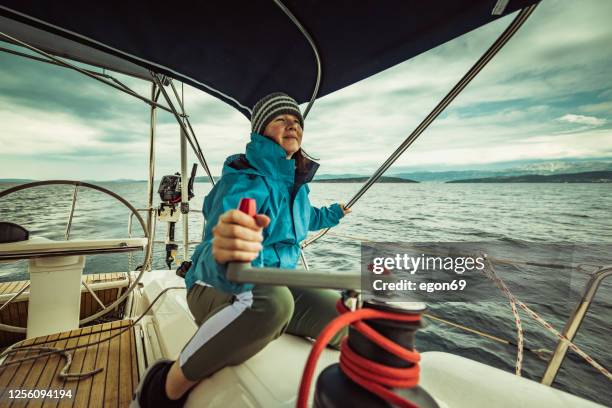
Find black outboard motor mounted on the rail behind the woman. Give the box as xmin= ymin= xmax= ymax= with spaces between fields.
xmin=157 ymin=163 xmax=198 ymax=269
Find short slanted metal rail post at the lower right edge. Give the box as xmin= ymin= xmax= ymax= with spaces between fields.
xmin=541 ymin=266 xmax=612 ymax=385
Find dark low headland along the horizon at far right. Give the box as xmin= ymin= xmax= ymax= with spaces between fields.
xmin=447 ymin=171 xmax=612 ymax=183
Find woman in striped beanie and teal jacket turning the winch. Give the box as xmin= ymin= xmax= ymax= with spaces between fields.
xmin=133 ymin=93 xmax=350 ymax=407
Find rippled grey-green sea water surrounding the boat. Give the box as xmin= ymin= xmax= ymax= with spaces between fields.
xmin=0 ymin=182 xmax=612 ymax=405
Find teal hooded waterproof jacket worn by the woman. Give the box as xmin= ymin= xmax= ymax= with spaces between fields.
xmin=185 ymin=133 xmax=344 ymax=293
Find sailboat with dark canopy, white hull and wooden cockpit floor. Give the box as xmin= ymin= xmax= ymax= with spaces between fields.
xmin=0 ymin=0 xmax=611 ymax=407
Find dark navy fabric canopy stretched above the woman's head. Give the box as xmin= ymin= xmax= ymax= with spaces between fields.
xmin=0 ymin=0 xmax=537 ymax=117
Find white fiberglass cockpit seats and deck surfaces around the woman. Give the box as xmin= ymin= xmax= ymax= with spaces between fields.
xmin=131 ymin=271 xmax=601 ymax=408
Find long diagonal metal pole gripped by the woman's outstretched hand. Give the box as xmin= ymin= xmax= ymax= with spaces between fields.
xmin=302 ymin=3 xmax=537 ymax=248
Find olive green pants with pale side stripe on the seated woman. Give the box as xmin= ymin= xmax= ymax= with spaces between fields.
xmin=179 ymin=284 xmax=347 ymax=381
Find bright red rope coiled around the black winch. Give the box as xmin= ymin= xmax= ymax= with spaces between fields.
xmin=297 ymin=301 xmax=421 ymax=408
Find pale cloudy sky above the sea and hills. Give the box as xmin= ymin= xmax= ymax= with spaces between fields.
xmin=0 ymin=0 xmax=612 ymax=180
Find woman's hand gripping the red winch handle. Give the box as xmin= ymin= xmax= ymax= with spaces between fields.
xmin=212 ymin=210 xmax=270 ymax=264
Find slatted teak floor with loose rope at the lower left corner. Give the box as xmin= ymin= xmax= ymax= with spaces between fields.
xmin=0 ymin=320 xmax=139 ymax=408
